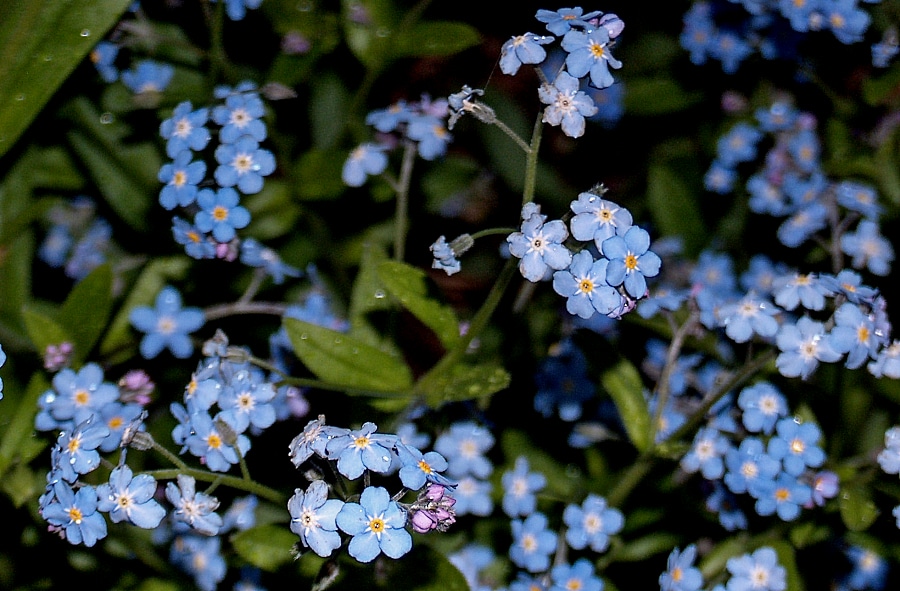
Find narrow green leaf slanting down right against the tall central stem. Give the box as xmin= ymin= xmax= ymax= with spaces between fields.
xmin=378 ymin=261 xmax=459 ymax=349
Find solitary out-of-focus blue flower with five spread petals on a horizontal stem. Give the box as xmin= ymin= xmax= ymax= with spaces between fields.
xmin=128 ymin=286 xmax=206 ymax=359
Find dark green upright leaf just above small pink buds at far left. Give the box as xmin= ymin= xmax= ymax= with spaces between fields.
xmin=58 ymin=264 xmax=113 ymax=359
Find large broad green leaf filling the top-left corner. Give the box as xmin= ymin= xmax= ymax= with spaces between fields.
xmin=0 ymin=0 xmax=131 ymax=162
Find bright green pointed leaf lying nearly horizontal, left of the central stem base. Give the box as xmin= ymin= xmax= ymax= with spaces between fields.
xmin=284 ymin=317 xmax=412 ymax=394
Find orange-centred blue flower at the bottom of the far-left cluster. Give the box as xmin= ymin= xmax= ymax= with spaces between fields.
xmin=41 ymin=480 xmax=107 ymax=547
